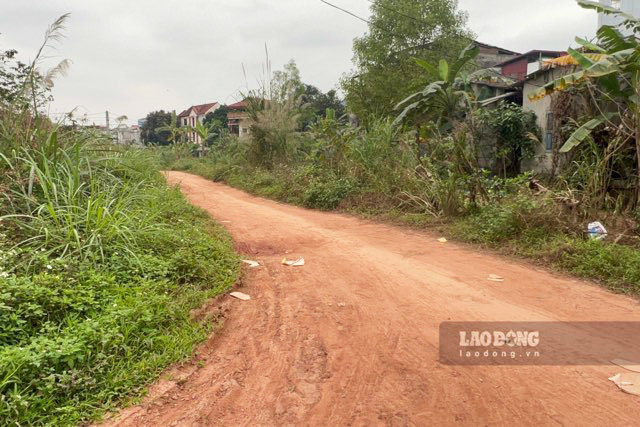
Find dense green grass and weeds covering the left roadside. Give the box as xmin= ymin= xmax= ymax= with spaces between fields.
xmin=0 ymin=16 xmax=239 ymax=426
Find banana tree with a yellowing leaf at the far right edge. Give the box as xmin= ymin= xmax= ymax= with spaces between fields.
xmin=530 ymin=0 xmax=640 ymax=205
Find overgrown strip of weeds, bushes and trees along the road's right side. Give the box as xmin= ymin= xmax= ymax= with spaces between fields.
xmin=157 ymin=2 xmax=640 ymax=295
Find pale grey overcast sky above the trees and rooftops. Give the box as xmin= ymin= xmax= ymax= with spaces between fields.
xmin=0 ymin=0 xmax=597 ymax=124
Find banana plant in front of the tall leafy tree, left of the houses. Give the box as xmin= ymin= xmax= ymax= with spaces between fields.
xmin=395 ymin=44 xmax=480 ymax=131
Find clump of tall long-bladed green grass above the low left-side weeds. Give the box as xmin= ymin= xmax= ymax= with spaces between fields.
xmin=2 ymin=137 xmax=157 ymax=262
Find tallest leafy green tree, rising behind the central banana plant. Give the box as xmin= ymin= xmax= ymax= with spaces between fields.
xmin=342 ymin=0 xmax=472 ymax=120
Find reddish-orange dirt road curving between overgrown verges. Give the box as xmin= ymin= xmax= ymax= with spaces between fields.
xmin=107 ymin=172 xmax=640 ymax=426
